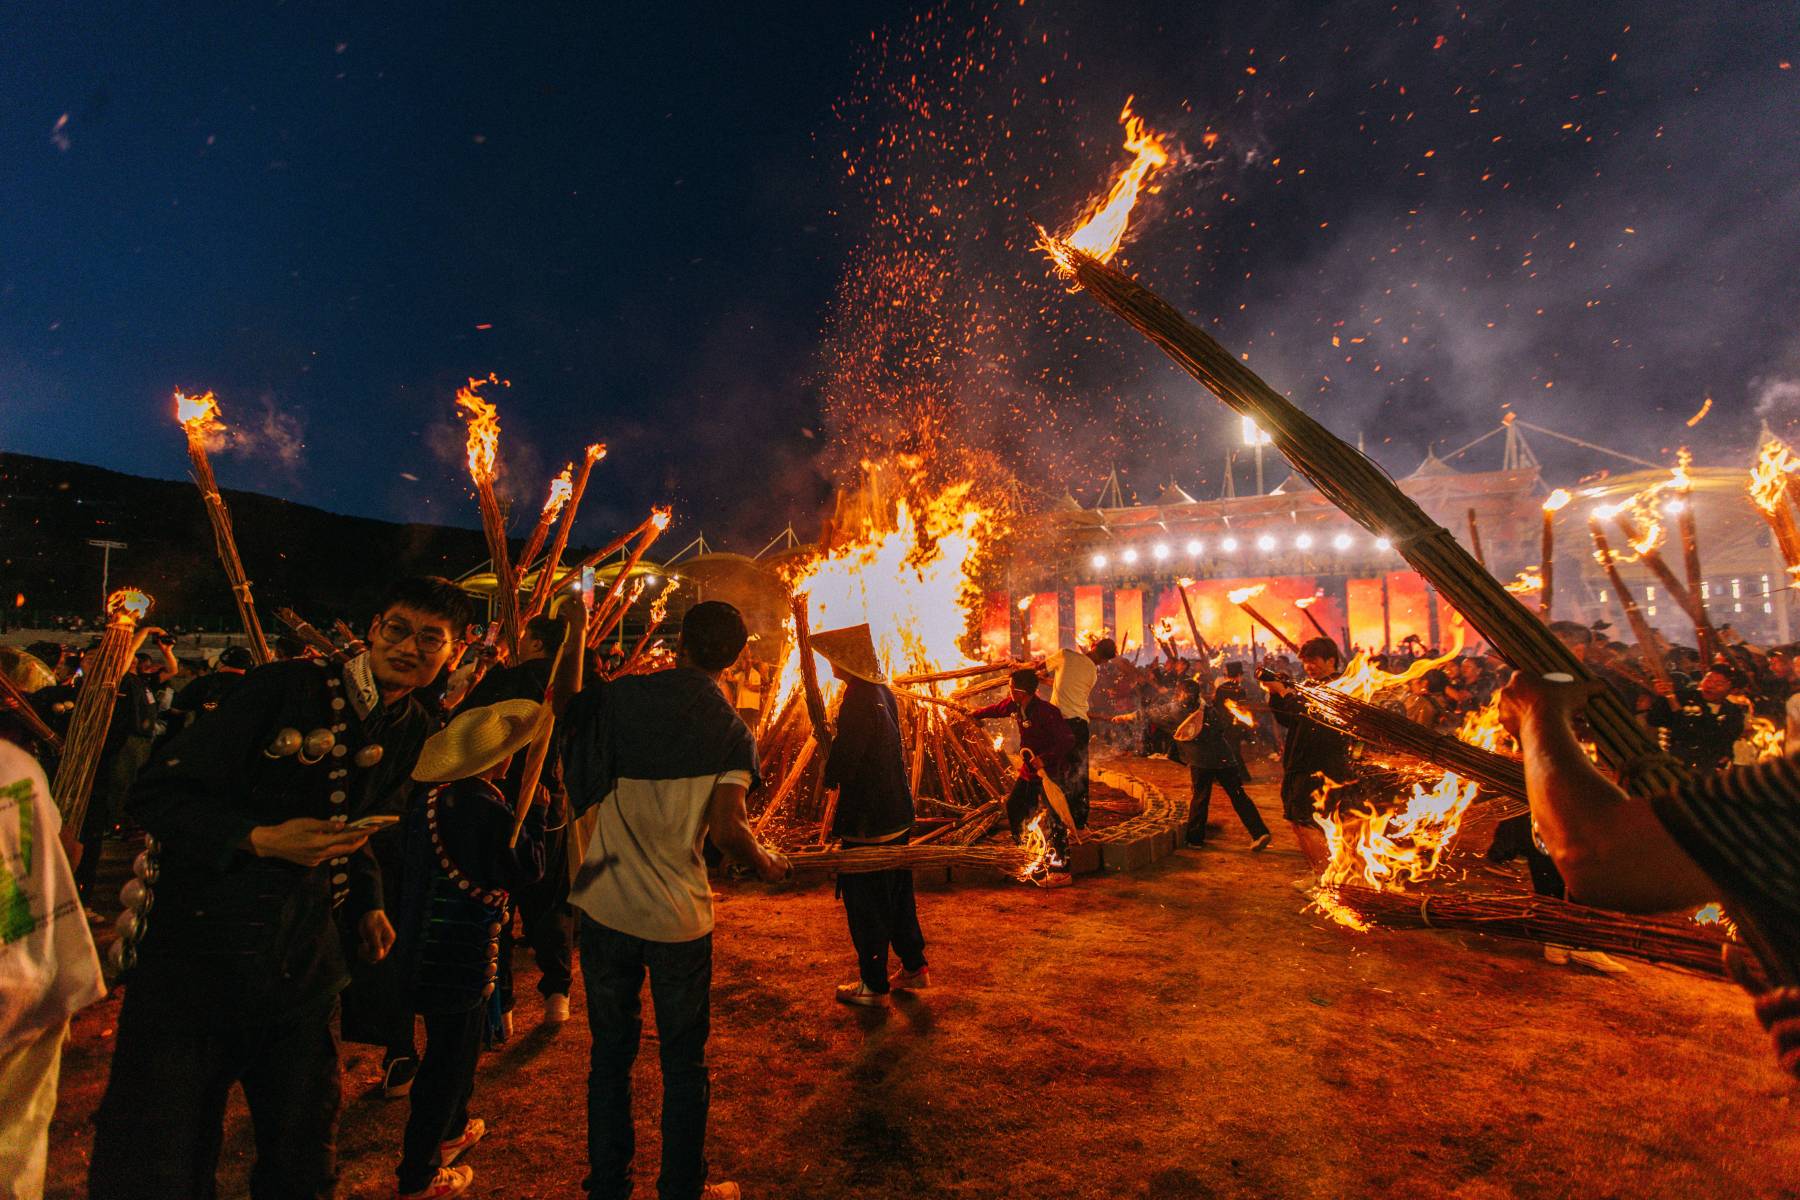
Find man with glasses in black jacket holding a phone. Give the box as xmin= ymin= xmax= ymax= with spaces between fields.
xmin=88 ymin=576 xmax=470 ymax=1200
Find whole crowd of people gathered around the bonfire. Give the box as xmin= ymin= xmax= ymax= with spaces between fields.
xmin=0 ymin=578 xmax=1800 ymax=1200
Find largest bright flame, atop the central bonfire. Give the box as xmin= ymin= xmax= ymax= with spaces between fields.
xmin=776 ymin=482 xmax=995 ymax=711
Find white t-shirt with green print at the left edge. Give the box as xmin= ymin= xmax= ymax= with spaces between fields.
xmin=0 ymin=741 xmax=106 ymax=1051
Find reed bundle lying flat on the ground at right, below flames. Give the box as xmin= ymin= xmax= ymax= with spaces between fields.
xmin=1321 ymin=887 xmax=1726 ymax=975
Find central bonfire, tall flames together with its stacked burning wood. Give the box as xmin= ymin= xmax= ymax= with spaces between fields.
xmin=758 ymin=468 xmax=1008 ymax=844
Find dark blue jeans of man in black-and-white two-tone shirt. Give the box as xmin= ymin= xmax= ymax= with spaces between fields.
xmin=581 ymin=912 xmax=713 ymax=1200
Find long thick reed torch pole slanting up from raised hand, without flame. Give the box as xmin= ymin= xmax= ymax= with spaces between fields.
xmin=1053 ymin=243 xmax=1690 ymax=793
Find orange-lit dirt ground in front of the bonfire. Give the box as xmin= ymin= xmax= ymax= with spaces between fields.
xmin=38 ymin=761 xmax=1800 ymax=1200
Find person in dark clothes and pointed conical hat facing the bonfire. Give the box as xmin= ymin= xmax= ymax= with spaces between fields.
xmin=812 ymin=624 xmax=931 ymax=1007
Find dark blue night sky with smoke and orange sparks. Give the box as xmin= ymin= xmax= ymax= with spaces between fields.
xmin=0 ymin=0 xmax=1800 ymax=552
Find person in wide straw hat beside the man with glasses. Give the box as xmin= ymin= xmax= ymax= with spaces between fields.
xmin=394 ymin=700 xmax=547 ymax=1200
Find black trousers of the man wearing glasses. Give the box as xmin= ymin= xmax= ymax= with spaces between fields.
xmin=88 ymin=982 xmax=342 ymax=1200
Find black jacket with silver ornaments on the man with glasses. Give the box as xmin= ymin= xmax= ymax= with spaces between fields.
xmin=130 ymin=657 xmax=432 ymax=1024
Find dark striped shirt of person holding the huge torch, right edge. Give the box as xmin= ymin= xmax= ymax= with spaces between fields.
xmin=1651 ymin=757 xmax=1800 ymax=984
